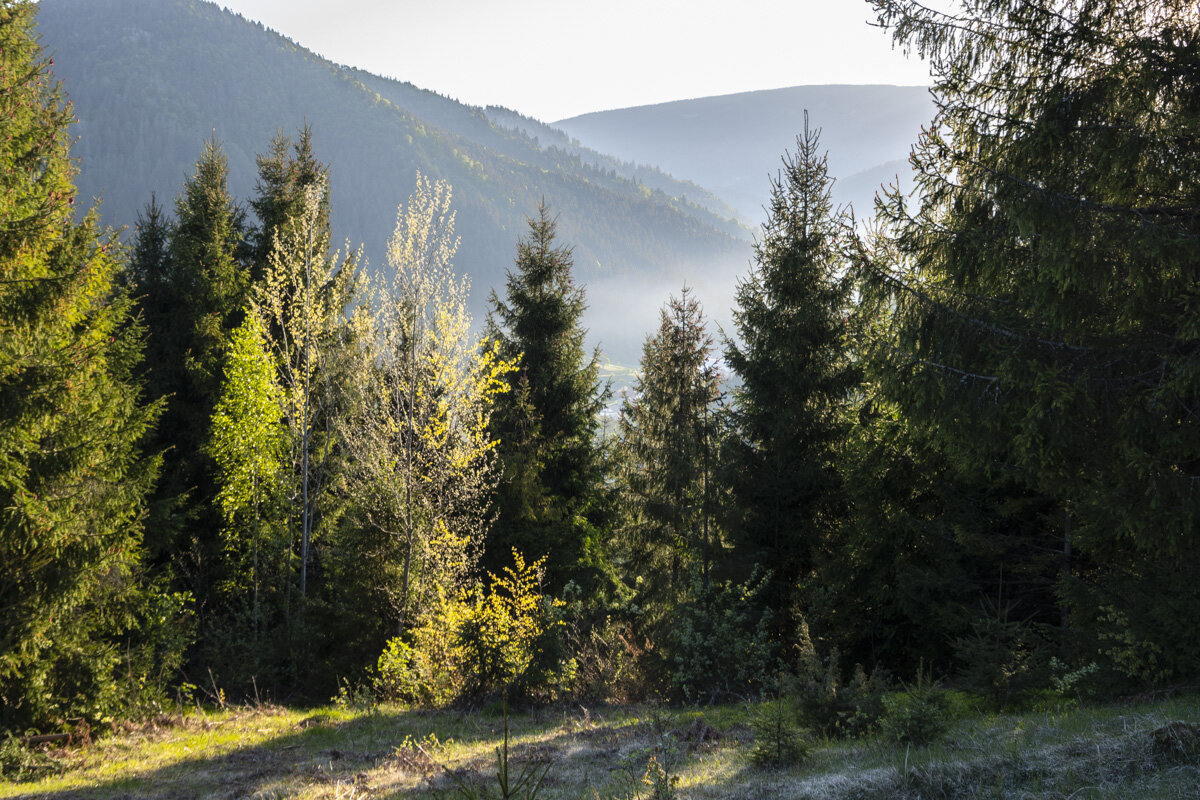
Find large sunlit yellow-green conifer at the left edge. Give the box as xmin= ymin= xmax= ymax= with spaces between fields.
xmin=0 ymin=0 xmax=157 ymax=730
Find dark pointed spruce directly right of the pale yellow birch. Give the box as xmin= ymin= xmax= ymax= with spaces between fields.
xmin=485 ymin=204 xmax=611 ymax=589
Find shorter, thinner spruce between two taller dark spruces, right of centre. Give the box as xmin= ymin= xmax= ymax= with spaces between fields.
xmin=620 ymin=287 xmax=720 ymax=608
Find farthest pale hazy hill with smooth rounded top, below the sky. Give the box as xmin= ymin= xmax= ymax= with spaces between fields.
xmin=553 ymin=85 xmax=934 ymax=223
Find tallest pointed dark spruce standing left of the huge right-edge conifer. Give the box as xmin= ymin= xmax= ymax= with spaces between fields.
xmin=725 ymin=119 xmax=854 ymax=625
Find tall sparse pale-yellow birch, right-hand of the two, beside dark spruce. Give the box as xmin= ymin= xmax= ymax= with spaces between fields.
xmin=342 ymin=174 xmax=514 ymax=633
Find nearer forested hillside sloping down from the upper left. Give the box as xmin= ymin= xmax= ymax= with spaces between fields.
xmin=38 ymin=0 xmax=750 ymax=363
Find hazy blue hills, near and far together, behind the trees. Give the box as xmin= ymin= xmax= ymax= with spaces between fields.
xmin=38 ymin=0 xmax=932 ymax=366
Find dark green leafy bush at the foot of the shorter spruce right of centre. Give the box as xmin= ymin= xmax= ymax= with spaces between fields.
xmin=665 ymin=570 xmax=776 ymax=702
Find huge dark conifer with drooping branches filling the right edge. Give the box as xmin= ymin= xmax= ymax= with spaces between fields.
xmin=860 ymin=0 xmax=1200 ymax=679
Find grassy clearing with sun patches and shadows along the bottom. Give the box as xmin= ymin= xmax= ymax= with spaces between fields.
xmin=0 ymin=697 xmax=1200 ymax=800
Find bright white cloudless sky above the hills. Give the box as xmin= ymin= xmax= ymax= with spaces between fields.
xmin=217 ymin=0 xmax=929 ymax=122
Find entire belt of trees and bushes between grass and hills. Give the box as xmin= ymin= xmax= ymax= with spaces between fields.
xmin=0 ymin=0 xmax=1200 ymax=796
